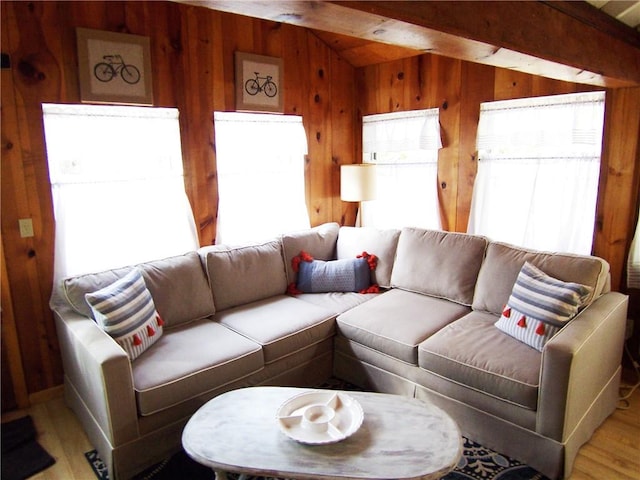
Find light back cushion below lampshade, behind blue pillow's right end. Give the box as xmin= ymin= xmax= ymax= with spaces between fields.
xmin=336 ymin=227 xmax=400 ymax=288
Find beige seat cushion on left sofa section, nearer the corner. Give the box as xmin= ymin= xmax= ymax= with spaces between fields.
xmin=214 ymin=295 xmax=335 ymax=364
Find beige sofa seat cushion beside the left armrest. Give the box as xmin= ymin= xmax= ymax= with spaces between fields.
xmin=132 ymin=319 xmax=264 ymax=415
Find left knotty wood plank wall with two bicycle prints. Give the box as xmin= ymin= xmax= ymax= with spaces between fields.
xmin=1 ymin=1 xmax=358 ymax=410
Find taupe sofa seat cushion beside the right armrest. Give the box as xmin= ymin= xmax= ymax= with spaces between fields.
xmin=418 ymin=312 xmax=542 ymax=410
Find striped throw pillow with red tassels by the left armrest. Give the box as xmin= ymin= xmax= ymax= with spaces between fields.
xmin=85 ymin=269 xmax=164 ymax=360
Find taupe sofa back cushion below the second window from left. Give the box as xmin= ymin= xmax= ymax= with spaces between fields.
xmin=199 ymin=240 xmax=287 ymax=310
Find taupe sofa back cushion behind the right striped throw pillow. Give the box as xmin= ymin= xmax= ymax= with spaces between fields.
xmin=472 ymin=242 xmax=610 ymax=315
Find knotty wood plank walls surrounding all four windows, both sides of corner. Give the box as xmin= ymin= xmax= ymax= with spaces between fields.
xmin=0 ymin=1 xmax=640 ymax=410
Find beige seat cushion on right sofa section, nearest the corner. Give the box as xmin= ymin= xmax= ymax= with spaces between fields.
xmin=337 ymin=290 xmax=470 ymax=365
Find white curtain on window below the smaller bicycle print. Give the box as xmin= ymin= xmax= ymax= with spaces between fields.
xmin=214 ymin=112 xmax=310 ymax=244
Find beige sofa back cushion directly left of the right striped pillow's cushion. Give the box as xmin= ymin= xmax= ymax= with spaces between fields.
xmin=391 ymin=228 xmax=488 ymax=305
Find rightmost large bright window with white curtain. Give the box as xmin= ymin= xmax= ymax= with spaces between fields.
xmin=468 ymin=92 xmax=604 ymax=254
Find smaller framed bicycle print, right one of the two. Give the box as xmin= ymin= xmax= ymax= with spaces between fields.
xmin=235 ymin=52 xmax=284 ymax=113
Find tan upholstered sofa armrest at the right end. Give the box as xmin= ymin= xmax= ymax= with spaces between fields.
xmin=536 ymin=292 xmax=629 ymax=442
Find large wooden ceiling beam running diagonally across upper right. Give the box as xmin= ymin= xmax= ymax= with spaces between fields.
xmin=181 ymin=0 xmax=640 ymax=88
